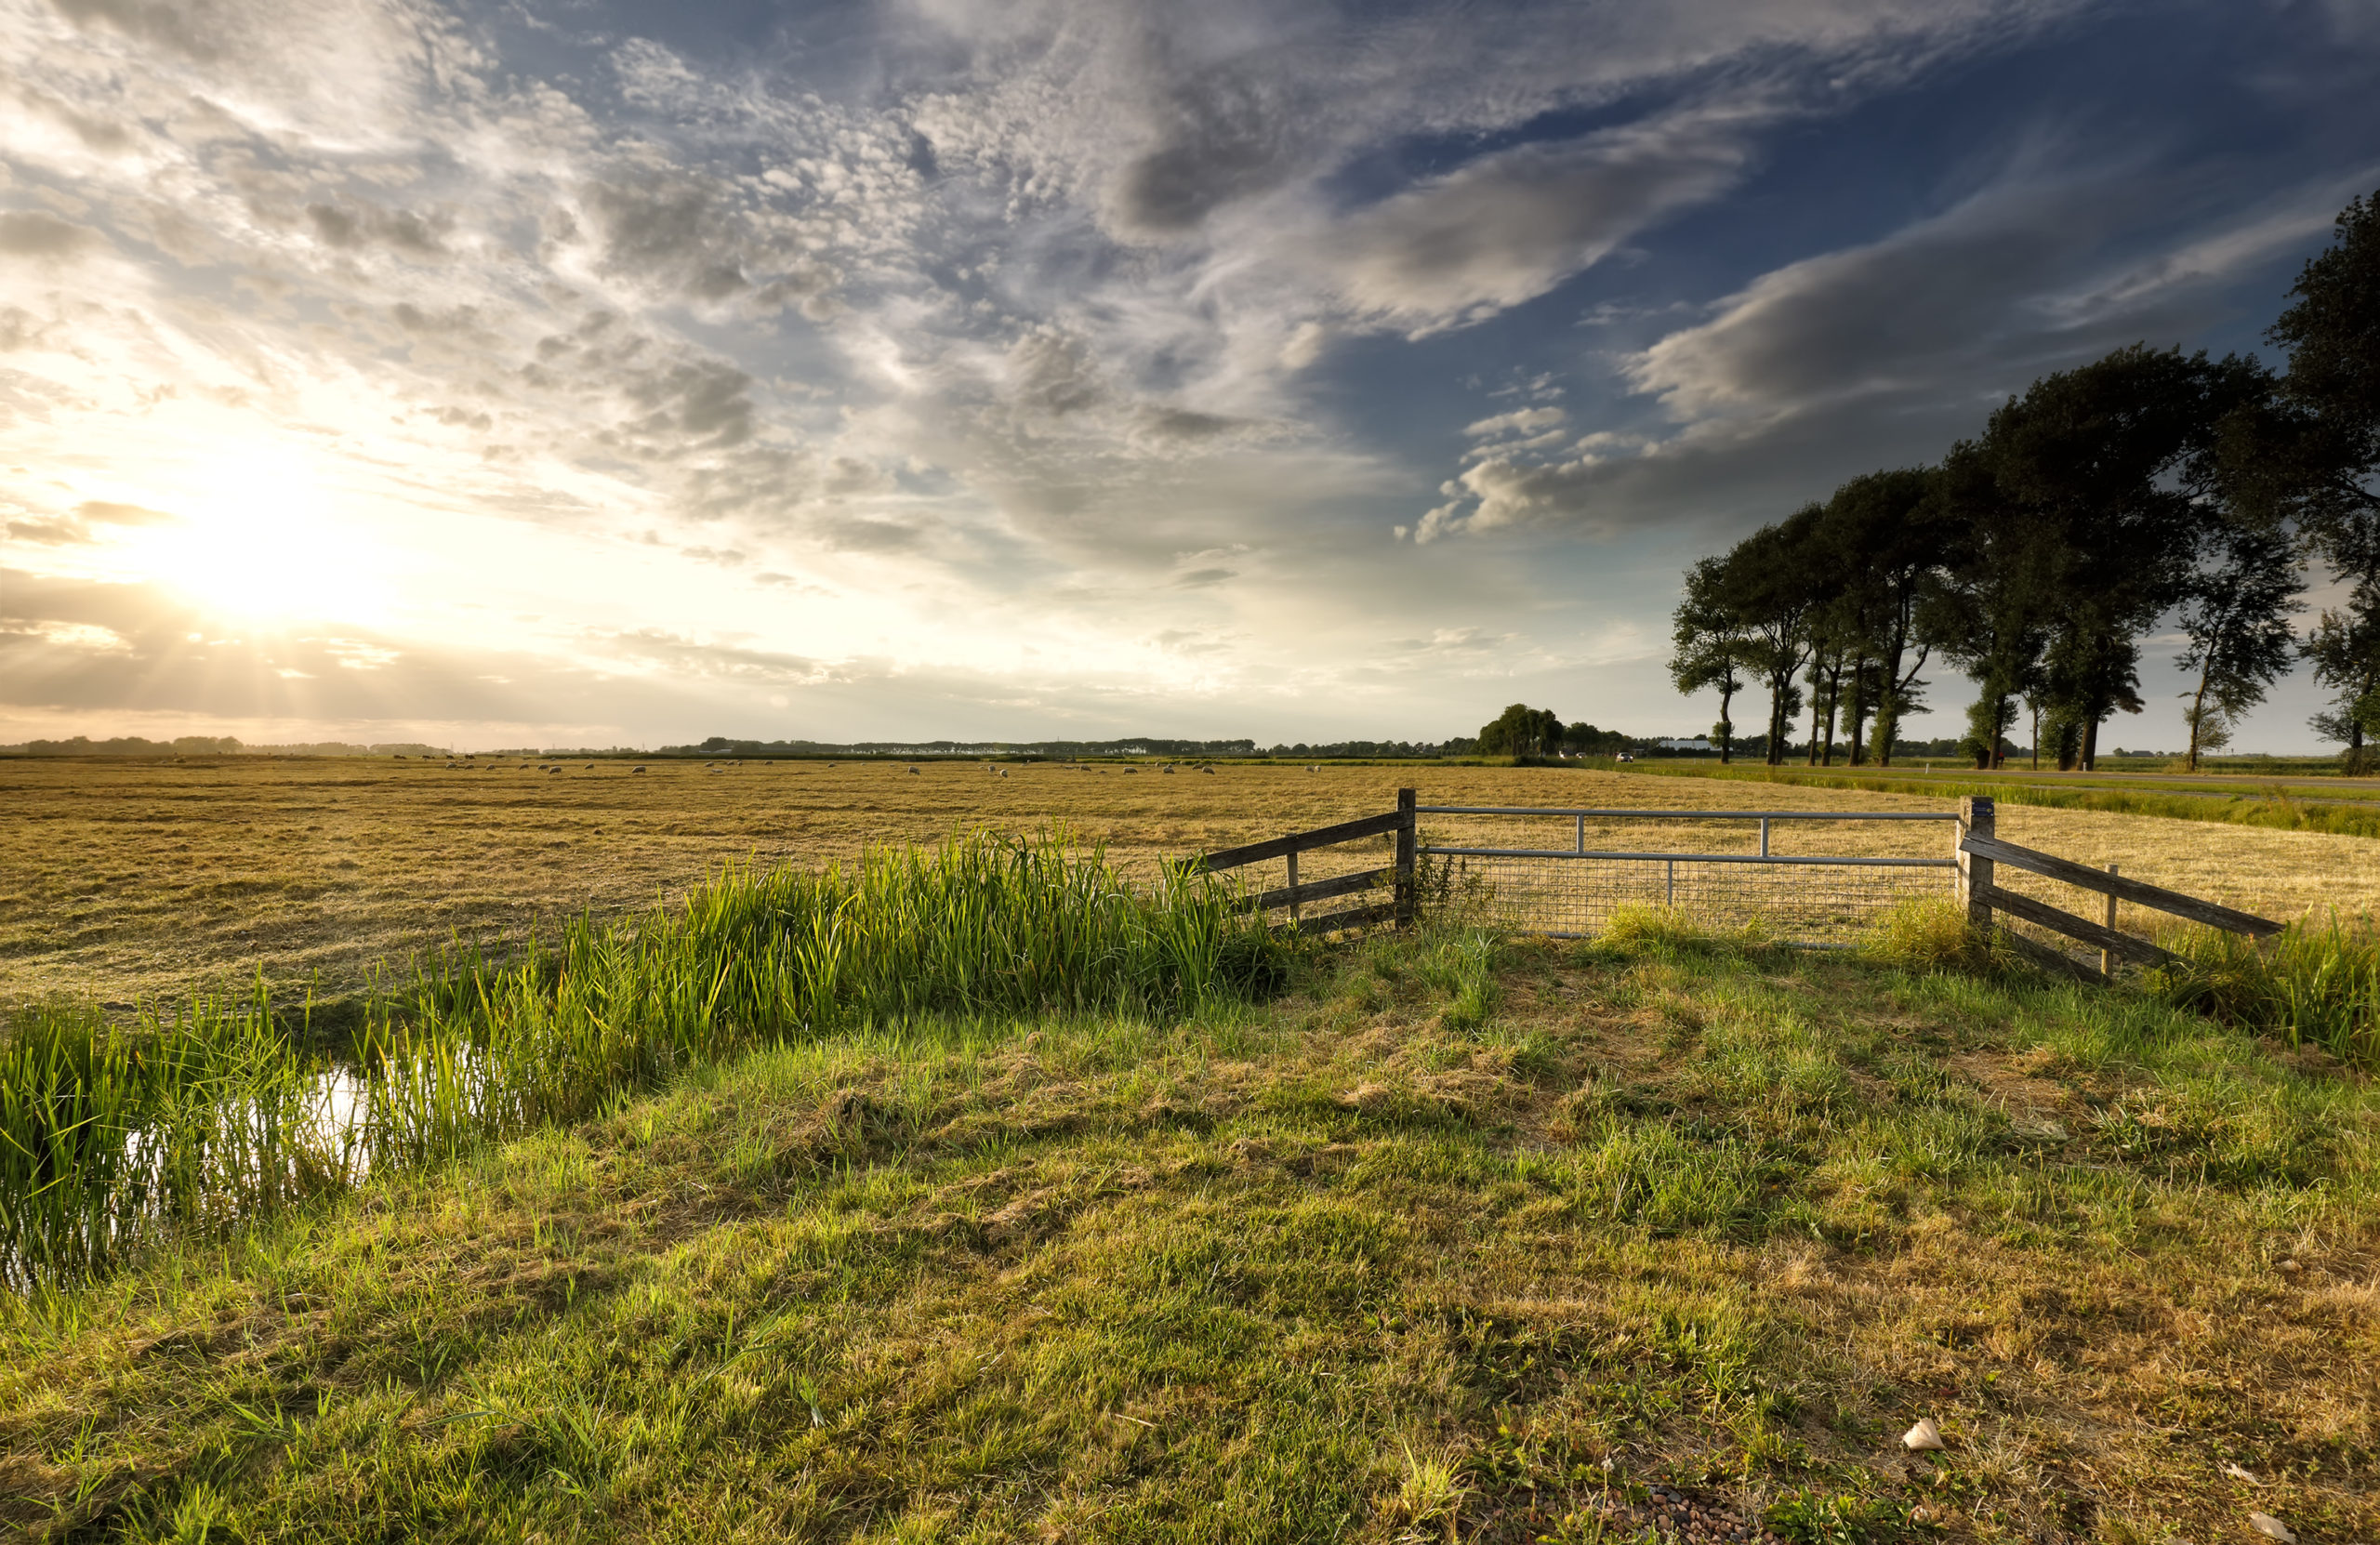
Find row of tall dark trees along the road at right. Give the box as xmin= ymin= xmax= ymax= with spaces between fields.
xmin=1671 ymin=195 xmax=2380 ymax=772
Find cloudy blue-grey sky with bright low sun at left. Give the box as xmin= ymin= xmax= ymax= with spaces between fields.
xmin=0 ymin=0 xmax=2380 ymax=752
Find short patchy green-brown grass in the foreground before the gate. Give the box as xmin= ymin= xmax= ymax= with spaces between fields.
xmin=0 ymin=917 xmax=2380 ymax=1545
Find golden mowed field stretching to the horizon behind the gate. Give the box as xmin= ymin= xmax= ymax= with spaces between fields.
xmin=0 ymin=757 xmax=2380 ymax=1010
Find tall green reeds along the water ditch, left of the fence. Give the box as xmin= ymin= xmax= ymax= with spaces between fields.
xmin=0 ymin=831 xmax=1285 ymax=1288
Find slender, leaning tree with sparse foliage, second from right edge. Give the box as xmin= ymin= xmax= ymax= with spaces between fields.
xmin=2175 ymin=523 xmax=2304 ymax=772
